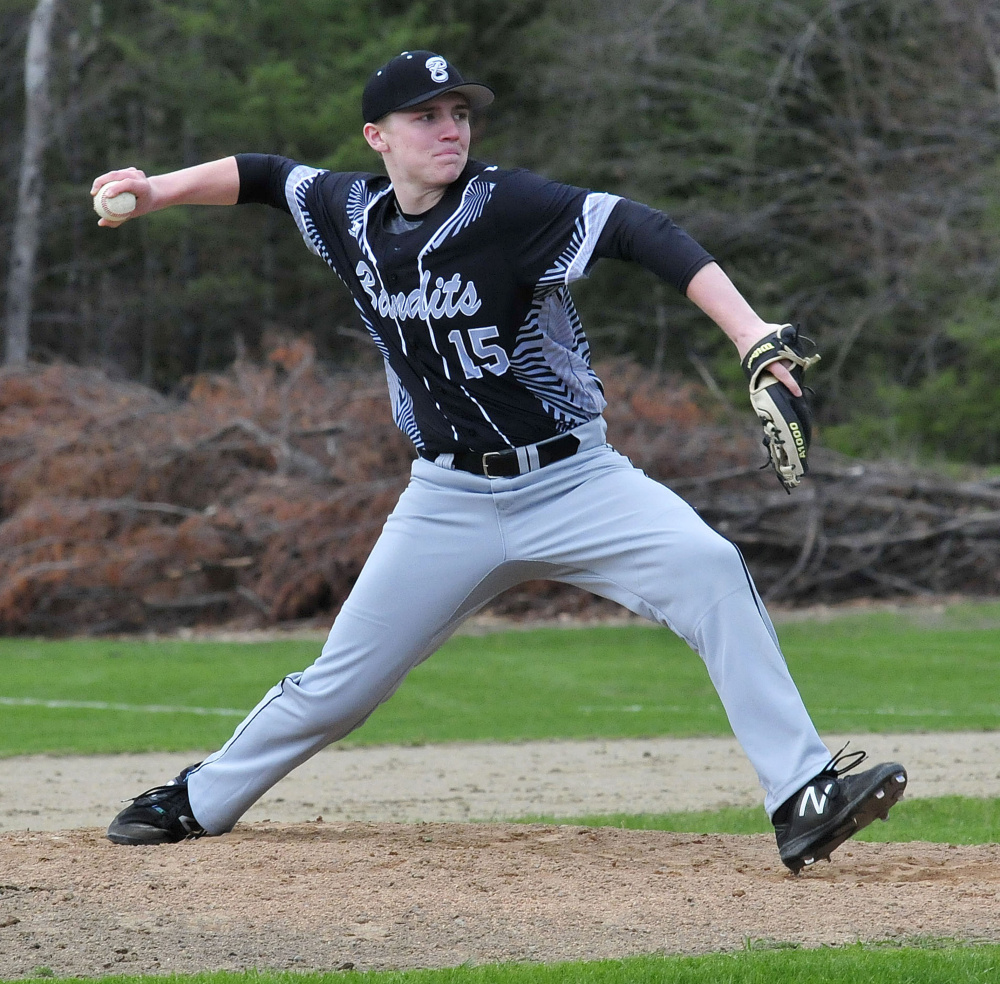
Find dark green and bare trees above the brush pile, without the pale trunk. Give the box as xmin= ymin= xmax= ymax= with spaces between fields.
xmin=7 ymin=0 xmax=1000 ymax=464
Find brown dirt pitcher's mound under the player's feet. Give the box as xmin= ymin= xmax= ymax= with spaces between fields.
xmin=0 ymin=822 xmax=1000 ymax=979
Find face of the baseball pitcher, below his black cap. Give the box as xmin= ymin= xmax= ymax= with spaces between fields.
xmin=378 ymin=93 xmax=470 ymax=198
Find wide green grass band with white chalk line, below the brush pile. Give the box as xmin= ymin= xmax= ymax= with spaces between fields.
xmin=0 ymin=605 xmax=1000 ymax=755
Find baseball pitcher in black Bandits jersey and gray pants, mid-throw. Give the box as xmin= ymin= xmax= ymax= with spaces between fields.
xmin=92 ymin=51 xmax=906 ymax=872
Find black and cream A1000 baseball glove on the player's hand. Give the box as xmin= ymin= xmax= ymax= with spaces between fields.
xmin=742 ymin=325 xmax=819 ymax=493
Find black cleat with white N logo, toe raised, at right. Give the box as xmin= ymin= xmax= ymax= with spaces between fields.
xmin=772 ymin=745 xmax=906 ymax=875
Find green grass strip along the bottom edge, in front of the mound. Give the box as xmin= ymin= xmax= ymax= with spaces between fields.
xmin=29 ymin=939 xmax=1000 ymax=984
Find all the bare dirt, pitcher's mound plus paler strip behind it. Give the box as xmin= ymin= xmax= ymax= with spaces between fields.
xmin=0 ymin=732 xmax=1000 ymax=980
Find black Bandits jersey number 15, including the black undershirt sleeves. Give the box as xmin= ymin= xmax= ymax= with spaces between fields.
xmin=237 ymin=154 xmax=711 ymax=457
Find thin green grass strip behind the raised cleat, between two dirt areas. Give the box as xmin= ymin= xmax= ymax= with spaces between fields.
xmin=515 ymin=796 xmax=1000 ymax=844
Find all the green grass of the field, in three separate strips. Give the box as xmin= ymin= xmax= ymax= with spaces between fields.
xmin=0 ymin=605 xmax=1000 ymax=984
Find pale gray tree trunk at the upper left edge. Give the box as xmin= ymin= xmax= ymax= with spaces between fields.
xmin=4 ymin=0 xmax=58 ymax=366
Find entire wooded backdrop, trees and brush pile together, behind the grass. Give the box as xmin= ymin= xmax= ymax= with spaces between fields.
xmin=0 ymin=0 xmax=1000 ymax=633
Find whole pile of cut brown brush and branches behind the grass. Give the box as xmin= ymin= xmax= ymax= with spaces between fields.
xmin=0 ymin=341 xmax=1000 ymax=634
